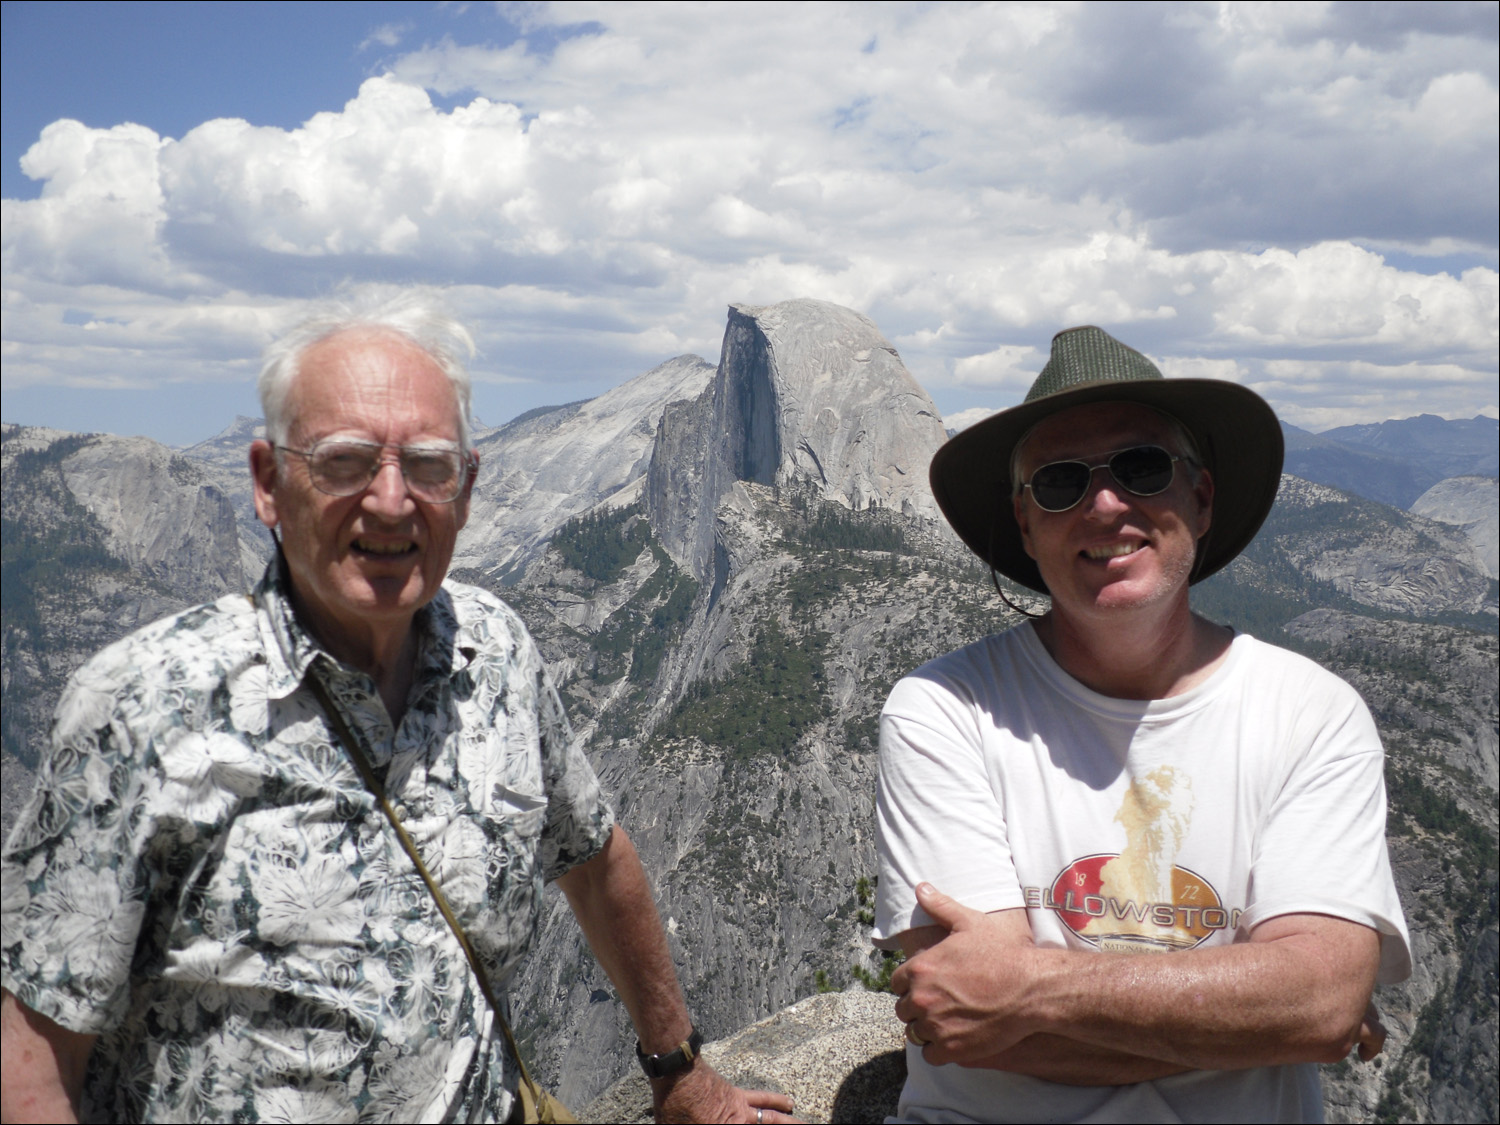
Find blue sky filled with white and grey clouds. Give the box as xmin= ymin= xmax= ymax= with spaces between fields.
xmin=0 ymin=3 xmax=1500 ymax=446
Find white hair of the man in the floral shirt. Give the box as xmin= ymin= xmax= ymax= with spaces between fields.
xmin=258 ymin=287 xmax=474 ymax=453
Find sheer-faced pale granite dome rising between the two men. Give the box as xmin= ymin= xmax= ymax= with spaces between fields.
xmin=645 ymin=297 xmax=947 ymax=582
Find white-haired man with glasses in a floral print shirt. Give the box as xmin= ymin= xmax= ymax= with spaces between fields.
xmin=0 ymin=294 xmax=791 ymax=1122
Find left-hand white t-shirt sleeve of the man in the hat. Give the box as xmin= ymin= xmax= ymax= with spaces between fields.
xmin=873 ymin=666 xmax=1025 ymax=950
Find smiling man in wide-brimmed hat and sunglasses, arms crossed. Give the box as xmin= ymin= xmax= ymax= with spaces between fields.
xmin=876 ymin=327 xmax=1410 ymax=1122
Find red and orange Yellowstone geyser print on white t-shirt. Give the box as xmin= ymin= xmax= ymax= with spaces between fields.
xmin=1026 ymin=767 xmax=1241 ymax=953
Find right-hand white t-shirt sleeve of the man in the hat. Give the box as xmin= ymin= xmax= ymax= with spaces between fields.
xmin=1242 ymin=669 xmax=1412 ymax=984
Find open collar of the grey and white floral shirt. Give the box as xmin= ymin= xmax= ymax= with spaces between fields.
xmin=251 ymin=551 xmax=477 ymax=699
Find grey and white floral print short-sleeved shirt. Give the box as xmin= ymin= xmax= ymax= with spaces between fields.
xmin=0 ymin=564 xmax=614 ymax=1122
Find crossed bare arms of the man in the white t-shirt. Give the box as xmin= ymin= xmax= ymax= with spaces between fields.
xmin=891 ymin=888 xmax=1380 ymax=1085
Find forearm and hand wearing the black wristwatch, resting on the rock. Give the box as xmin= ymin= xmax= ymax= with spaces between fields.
xmin=558 ymin=825 xmax=792 ymax=1122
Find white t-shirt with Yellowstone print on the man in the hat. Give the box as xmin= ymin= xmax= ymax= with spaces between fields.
xmin=875 ymin=626 xmax=1412 ymax=1122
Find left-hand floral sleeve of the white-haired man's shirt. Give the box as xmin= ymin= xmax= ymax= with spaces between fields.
xmin=0 ymin=645 xmax=152 ymax=1035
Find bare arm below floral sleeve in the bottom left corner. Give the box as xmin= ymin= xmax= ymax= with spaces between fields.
xmin=0 ymin=989 xmax=98 ymax=1122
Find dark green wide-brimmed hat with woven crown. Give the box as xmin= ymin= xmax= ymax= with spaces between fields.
xmin=929 ymin=326 xmax=1284 ymax=594
